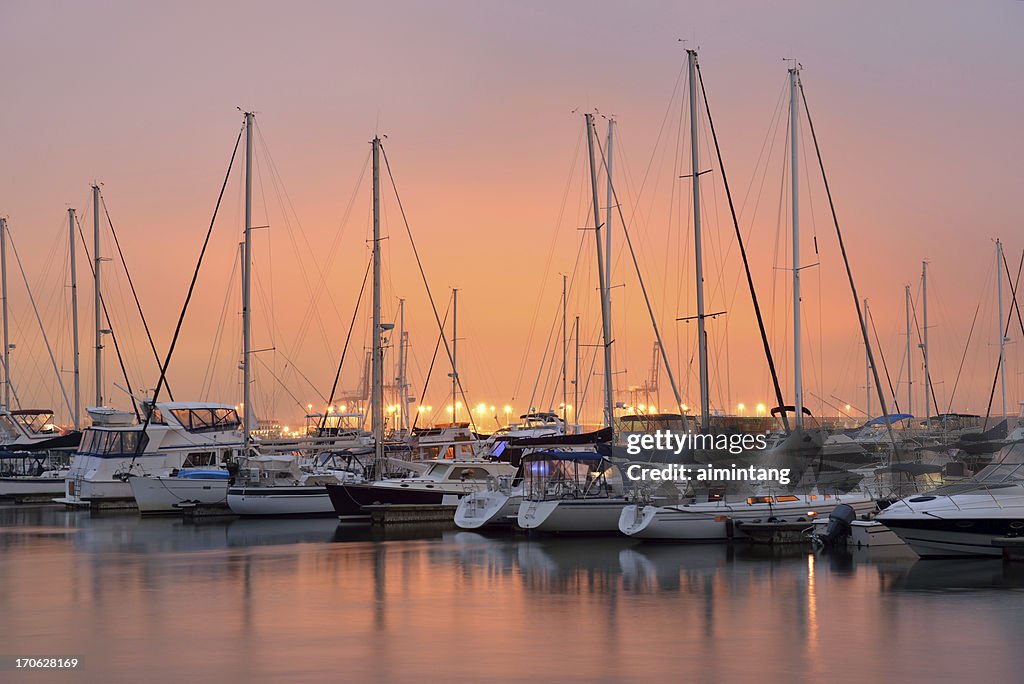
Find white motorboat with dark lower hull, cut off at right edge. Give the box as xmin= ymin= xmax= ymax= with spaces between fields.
xmin=876 ymin=442 xmax=1024 ymax=558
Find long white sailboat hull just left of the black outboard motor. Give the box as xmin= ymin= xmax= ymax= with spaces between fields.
xmin=617 ymin=495 xmax=874 ymax=542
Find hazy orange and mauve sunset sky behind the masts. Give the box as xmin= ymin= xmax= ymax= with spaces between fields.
xmin=0 ymin=0 xmax=1024 ymax=428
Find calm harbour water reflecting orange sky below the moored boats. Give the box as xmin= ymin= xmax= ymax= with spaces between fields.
xmin=0 ymin=507 xmax=1024 ymax=684
